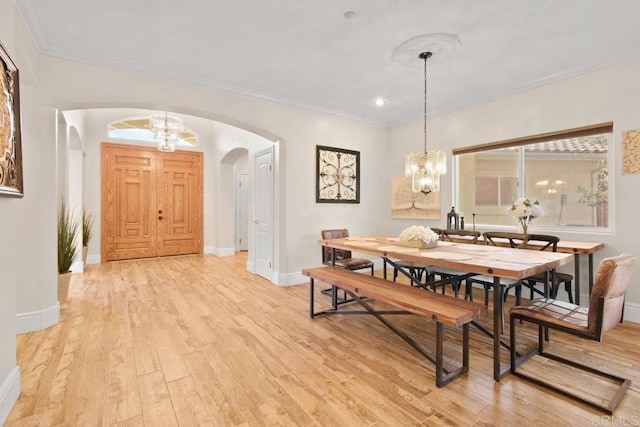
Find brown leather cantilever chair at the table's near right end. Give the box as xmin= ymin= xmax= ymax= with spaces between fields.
xmin=509 ymin=254 xmax=636 ymax=414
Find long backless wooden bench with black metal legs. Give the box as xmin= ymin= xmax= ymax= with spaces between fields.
xmin=302 ymin=267 xmax=487 ymax=387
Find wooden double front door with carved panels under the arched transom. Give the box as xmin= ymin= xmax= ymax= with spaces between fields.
xmin=102 ymin=144 xmax=202 ymax=261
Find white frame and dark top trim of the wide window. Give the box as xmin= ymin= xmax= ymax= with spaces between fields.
xmin=452 ymin=122 xmax=615 ymax=234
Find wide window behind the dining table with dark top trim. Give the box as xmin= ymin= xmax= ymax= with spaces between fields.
xmin=453 ymin=123 xmax=613 ymax=230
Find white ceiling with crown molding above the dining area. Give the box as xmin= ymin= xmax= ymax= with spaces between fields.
xmin=16 ymin=0 xmax=640 ymax=126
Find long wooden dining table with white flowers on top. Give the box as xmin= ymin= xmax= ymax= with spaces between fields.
xmin=318 ymin=235 xmax=574 ymax=381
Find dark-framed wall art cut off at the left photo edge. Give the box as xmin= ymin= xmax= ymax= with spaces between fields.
xmin=0 ymin=44 xmax=24 ymax=197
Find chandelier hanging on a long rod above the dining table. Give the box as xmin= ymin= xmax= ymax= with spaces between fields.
xmin=404 ymin=52 xmax=447 ymax=194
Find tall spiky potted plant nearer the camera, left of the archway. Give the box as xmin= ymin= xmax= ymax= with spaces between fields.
xmin=58 ymin=199 xmax=80 ymax=304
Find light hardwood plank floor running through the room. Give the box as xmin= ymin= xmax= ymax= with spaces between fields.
xmin=7 ymin=255 xmax=640 ymax=426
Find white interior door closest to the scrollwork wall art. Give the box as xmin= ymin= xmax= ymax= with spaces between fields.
xmin=254 ymin=149 xmax=273 ymax=280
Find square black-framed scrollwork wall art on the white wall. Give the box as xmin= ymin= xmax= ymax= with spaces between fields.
xmin=316 ymin=145 xmax=360 ymax=203
